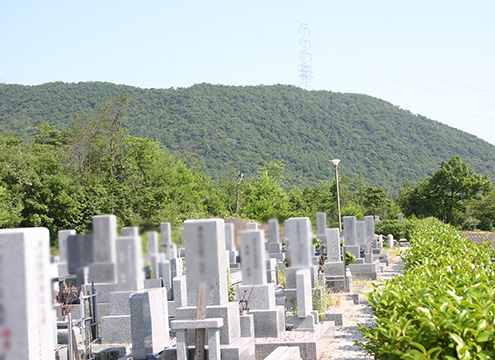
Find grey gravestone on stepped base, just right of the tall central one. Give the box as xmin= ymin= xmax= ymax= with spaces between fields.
xmin=236 ymin=230 xmax=285 ymax=338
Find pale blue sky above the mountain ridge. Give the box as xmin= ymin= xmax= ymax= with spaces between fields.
xmin=0 ymin=0 xmax=495 ymax=145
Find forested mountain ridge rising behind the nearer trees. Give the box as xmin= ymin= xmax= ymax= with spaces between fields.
xmin=0 ymin=82 xmax=495 ymax=194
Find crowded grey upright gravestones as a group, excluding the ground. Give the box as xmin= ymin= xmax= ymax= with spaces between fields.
xmin=0 ymin=213 xmax=388 ymax=359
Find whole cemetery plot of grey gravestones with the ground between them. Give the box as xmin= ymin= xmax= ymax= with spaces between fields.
xmin=0 ymin=213 xmax=406 ymax=360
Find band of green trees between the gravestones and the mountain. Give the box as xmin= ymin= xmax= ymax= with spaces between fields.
xmin=0 ymin=94 xmax=495 ymax=250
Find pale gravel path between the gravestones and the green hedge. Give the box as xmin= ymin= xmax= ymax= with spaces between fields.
xmin=319 ymin=253 xmax=403 ymax=360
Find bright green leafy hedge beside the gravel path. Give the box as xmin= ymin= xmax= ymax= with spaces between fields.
xmin=360 ymin=219 xmax=495 ymax=359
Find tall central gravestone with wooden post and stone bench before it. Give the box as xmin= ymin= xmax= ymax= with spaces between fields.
xmin=170 ymin=219 xmax=254 ymax=359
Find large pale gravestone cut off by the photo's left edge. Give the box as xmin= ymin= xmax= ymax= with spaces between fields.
xmin=0 ymin=228 xmax=55 ymax=360
